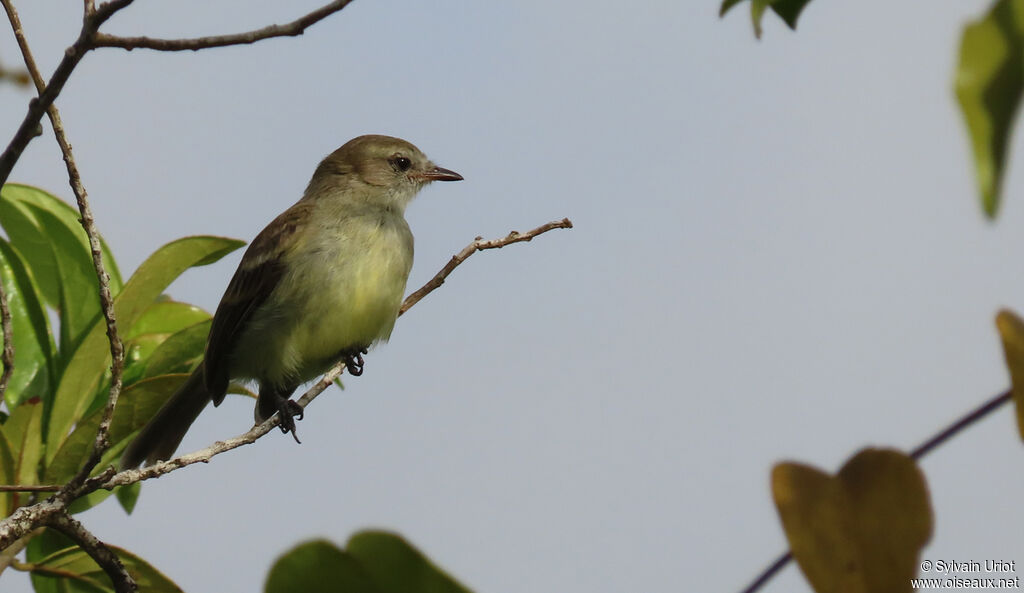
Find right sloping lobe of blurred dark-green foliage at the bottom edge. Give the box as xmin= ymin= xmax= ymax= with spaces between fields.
xmin=346 ymin=531 xmax=469 ymax=593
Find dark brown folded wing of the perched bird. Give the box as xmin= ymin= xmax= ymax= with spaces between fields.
xmin=203 ymin=202 xmax=309 ymax=406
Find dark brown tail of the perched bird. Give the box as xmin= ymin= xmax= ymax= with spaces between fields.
xmin=121 ymin=365 xmax=212 ymax=469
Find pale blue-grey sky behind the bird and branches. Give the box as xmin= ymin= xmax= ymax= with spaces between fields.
xmin=0 ymin=0 xmax=1024 ymax=593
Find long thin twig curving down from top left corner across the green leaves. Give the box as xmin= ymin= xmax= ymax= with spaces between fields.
xmin=0 ymin=0 xmax=125 ymax=492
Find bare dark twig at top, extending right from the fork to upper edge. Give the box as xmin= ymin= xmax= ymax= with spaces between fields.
xmin=92 ymin=0 xmax=352 ymax=51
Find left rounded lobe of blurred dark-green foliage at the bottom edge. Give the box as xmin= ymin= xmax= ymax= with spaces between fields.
xmin=263 ymin=540 xmax=380 ymax=593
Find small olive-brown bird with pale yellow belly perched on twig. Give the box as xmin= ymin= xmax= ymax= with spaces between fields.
xmin=121 ymin=136 xmax=462 ymax=468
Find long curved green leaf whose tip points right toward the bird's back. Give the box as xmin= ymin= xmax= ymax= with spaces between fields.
xmin=46 ymin=237 xmax=245 ymax=460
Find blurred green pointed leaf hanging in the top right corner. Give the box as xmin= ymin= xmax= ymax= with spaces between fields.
xmin=955 ymin=0 xmax=1024 ymax=218
